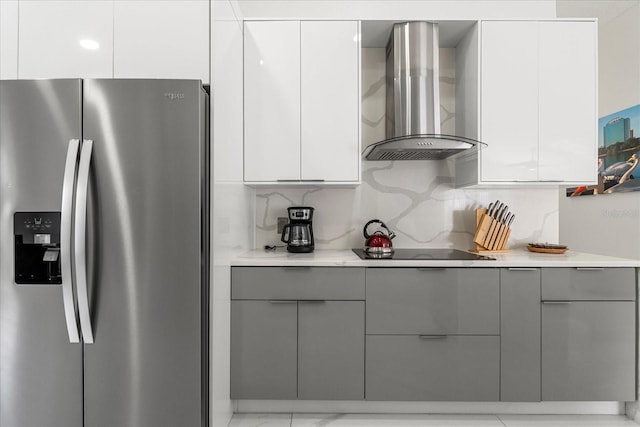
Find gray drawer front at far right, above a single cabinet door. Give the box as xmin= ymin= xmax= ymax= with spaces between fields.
xmin=542 ymin=268 xmax=636 ymax=301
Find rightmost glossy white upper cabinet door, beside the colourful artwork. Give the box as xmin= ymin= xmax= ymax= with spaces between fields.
xmin=538 ymin=22 xmax=598 ymax=183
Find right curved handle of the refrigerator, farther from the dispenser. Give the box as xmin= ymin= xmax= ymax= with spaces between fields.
xmin=74 ymin=139 xmax=93 ymax=344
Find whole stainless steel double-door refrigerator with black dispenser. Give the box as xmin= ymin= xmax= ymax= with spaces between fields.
xmin=0 ymin=79 xmax=209 ymax=427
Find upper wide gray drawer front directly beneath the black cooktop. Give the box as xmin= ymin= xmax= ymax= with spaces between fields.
xmin=366 ymin=268 xmax=500 ymax=335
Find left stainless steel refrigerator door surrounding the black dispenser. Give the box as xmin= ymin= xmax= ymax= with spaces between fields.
xmin=0 ymin=80 xmax=82 ymax=427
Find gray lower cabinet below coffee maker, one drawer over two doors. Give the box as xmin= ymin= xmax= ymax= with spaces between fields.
xmin=231 ymin=267 xmax=365 ymax=400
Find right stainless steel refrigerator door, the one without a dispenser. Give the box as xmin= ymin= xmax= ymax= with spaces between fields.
xmin=83 ymin=80 xmax=207 ymax=427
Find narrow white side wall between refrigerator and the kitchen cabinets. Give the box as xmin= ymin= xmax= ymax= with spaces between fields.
xmin=211 ymin=0 xmax=255 ymax=427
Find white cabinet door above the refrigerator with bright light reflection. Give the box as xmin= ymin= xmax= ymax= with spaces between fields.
xmin=18 ymin=0 xmax=113 ymax=79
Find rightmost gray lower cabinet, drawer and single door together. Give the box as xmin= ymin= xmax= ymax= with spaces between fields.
xmin=541 ymin=268 xmax=636 ymax=401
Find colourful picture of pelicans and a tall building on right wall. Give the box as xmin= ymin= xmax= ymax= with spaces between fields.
xmin=567 ymin=104 xmax=640 ymax=197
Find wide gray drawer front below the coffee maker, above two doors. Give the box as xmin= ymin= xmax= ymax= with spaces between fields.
xmin=231 ymin=267 xmax=365 ymax=300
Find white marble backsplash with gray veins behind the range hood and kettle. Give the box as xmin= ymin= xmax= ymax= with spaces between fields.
xmin=256 ymin=48 xmax=559 ymax=249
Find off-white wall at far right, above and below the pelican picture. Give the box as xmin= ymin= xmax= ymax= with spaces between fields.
xmin=558 ymin=0 xmax=640 ymax=259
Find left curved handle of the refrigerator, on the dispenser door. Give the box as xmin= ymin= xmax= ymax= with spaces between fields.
xmin=60 ymin=139 xmax=80 ymax=343
